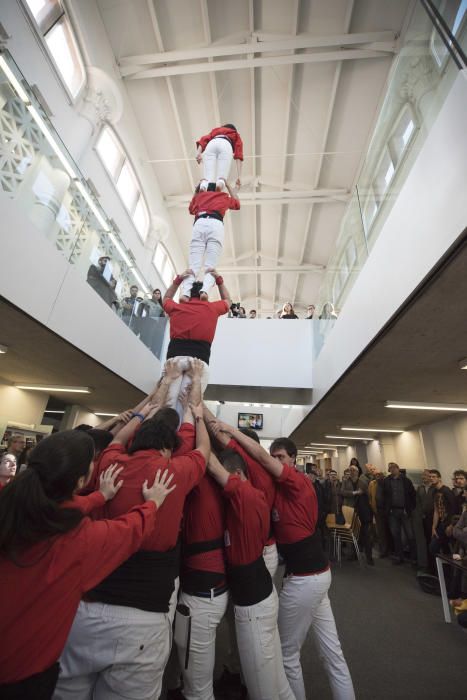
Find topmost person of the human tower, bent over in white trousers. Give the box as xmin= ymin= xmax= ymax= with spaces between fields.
xmin=196 ymin=124 xmax=243 ymax=192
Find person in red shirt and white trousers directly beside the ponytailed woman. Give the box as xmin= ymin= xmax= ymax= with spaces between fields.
xmin=55 ymin=380 xmax=210 ymax=700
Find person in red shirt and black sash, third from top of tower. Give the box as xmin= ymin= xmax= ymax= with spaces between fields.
xmin=163 ymin=270 xmax=231 ymax=420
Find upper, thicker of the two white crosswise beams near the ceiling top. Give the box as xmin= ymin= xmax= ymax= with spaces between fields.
xmin=119 ymin=31 xmax=396 ymax=70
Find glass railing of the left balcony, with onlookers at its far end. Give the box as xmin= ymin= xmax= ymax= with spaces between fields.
xmin=0 ymin=52 xmax=166 ymax=357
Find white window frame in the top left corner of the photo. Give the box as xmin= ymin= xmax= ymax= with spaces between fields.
xmin=20 ymin=0 xmax=88 ymax=105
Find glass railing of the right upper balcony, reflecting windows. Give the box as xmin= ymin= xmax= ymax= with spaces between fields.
xmin=314 ymin=0 xmax=467 ymax=356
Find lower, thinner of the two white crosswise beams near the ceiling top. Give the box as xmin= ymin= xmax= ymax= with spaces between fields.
xmin=121 ymin=44 xmax=395 ymax=80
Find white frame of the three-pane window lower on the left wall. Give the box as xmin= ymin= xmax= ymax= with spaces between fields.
xmin=94 ymin=123 xmax=151 ymax=244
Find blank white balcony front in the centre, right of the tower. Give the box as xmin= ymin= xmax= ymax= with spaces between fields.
xmin=210 ymin=318 xmax=313 ymax=389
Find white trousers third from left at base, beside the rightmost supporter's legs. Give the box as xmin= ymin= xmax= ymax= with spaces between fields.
xmin=234 ymin=589 xmax=295 ymax=700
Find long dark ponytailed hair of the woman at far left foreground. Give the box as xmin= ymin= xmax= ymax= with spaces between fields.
xmin=0 ymin=430 xmax=94 ymax=558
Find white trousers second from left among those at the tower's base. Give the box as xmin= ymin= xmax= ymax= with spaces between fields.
xmin=177 ymin=591 xmax=229 ymax=700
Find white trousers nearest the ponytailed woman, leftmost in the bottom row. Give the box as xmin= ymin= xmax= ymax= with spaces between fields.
xmin=53 ymin=602 xmax=172 ymax=700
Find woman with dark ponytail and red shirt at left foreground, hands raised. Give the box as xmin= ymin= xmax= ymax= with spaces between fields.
xmin=0 ymin=430 xmax=175 ymax=700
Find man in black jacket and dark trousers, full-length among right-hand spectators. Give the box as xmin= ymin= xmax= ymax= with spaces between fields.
xmin=384 ymin=462 xmax=416 ymax=564
